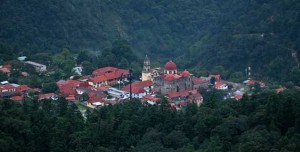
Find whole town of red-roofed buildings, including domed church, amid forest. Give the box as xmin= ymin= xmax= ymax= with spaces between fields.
xmin=0 ymin=55 xmax=290 ymax=110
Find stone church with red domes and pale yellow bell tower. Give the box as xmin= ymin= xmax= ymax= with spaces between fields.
xmin=142 ymin=56 xmax=193 ymax=95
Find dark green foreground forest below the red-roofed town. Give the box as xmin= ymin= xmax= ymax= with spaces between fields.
xmin=0 ymin=90 xmax=300 ymax=152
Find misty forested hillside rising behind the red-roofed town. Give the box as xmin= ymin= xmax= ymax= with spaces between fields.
xmin=0 ymin=0 xmax=300 ymax=84
